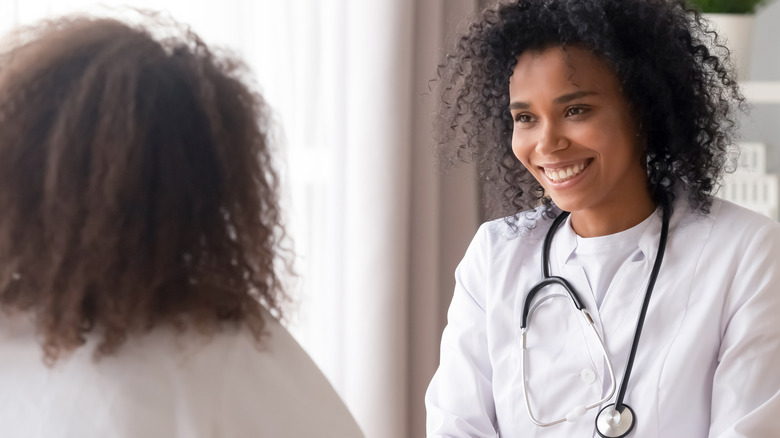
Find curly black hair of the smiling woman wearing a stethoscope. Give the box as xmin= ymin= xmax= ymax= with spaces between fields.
xmin=438 ymin=0 xmax=744 ymax=224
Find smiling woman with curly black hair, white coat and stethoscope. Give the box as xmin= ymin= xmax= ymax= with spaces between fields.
xmin=426 ymin=0 xmax=780 ymax=438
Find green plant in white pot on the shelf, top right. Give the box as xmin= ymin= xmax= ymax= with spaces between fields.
xmin=688 ymin=0 xmax=771 ymax=79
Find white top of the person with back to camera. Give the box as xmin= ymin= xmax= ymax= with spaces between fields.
xmin=0 ymin=314 xmax=363 ymax=438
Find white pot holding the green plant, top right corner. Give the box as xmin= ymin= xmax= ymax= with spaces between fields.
xmin=703 ymin=14 xmax=756 ymax=81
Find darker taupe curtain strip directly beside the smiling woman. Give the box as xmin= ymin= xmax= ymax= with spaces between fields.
xmin=404 ymin=0 xmax=479 ymax=437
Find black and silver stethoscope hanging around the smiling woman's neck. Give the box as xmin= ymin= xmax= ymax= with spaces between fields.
xmin=520 ymin=207 xmax=671 ymax=438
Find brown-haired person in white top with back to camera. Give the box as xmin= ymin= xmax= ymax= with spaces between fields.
xmin=0 ymin=16 xmax=362 ymax=438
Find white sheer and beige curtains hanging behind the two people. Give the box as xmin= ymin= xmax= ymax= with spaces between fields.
xmin=0 ymin=0 xmax=478 ymax=438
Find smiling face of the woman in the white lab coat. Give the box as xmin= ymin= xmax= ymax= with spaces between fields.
xmin=509 ymin=47 xmax=654 ymax=235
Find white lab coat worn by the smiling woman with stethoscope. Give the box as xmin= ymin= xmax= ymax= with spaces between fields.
xmin=426 ymin=194 xmax=780 ymax=438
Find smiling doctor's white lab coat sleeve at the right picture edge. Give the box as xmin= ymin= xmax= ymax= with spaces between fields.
xmin=709 ymin=223 xmax=780 ymax=438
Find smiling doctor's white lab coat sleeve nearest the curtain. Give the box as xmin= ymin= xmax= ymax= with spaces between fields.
xmin=425 ymin=225 xmax=498 ymax=438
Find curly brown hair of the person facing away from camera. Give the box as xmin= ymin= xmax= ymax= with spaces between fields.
xmin=0 ymin=15 xmax=290 ymax=363
